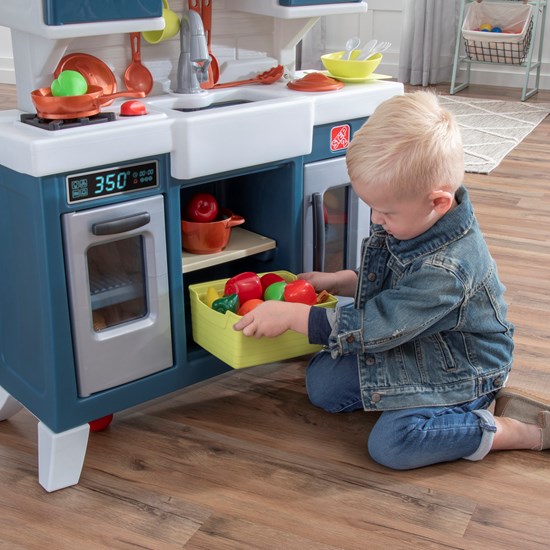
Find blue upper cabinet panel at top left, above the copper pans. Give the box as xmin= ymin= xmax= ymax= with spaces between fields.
xmin=43 ymin=0 xmax=162 ymax=25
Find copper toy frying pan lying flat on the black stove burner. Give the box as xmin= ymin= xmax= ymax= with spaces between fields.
xmin=31 ymin=86 xmax=145 ymax=120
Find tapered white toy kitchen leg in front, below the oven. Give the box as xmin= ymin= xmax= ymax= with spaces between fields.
xmin=38 ymin=422 xmax=90 ymax=492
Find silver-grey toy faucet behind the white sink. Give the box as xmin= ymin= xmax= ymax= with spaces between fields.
xmin=174 ymin=9 xmax=211 ymax=94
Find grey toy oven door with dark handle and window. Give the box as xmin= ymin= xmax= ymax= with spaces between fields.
xmin=63 ymin=195 xmax=173 ymax=396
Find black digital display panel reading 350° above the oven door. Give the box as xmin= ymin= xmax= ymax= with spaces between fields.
xmin=66 ymin=160 xmax=158 ymax=204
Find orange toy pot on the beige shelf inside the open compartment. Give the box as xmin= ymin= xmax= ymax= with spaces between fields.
xmin=181 ymin=208 xmax=244 ymax=254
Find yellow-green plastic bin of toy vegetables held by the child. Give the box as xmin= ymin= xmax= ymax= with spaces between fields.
xmin=189 ymin=271 xmax=337 ymax=369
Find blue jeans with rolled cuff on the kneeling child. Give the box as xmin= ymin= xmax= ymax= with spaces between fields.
xmin=306 ymin=352 xmax=496 ymax=470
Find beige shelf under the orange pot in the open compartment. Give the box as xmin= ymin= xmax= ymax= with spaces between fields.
xmin=181 ymin=227 xmax=277 ymax=273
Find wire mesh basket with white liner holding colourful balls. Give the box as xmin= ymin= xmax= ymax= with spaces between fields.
xmin=462 ymin=2 xmax=533 ymax=65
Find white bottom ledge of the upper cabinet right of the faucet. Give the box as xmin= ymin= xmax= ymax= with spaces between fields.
xmin=226 ymin=0 xmax=367 ymax=19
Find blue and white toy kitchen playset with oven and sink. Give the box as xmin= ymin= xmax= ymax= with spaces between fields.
xmin=0 ymin=0 xmax=403 ymax=491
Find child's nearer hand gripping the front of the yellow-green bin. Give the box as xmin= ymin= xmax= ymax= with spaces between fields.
xmin=233 ymin=300 xmax=311 ymax=338
